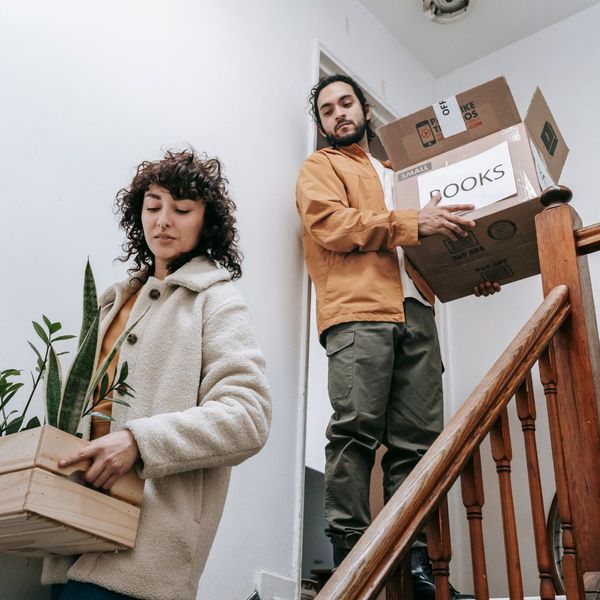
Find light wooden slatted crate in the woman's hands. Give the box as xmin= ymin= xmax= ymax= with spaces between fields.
xmin=0 ymin=425 xmax=144 ymax=557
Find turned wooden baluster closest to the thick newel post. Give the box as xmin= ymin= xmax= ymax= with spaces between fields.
xmin=539 ymin=349 xmax=585 ymax=600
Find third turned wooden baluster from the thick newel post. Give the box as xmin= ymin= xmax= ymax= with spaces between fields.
xmin=490 ymin=408 xmax=523 ymax=600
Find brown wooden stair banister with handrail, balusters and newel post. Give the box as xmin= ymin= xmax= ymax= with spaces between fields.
xmin=317 ymin=186 xmax=600 ymax=600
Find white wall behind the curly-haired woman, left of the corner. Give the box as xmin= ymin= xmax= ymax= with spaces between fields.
xmin=0 ymin=0 xmax=433 ymax=600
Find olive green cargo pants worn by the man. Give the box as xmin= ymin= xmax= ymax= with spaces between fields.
xmin=325 ymin=298 xmax=443 ymax=564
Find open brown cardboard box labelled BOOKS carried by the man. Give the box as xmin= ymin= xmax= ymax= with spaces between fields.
xmin=378 ymin=78 xmax=568 ymax=302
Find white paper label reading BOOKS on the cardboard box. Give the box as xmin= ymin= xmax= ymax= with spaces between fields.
xmin=417 ymin=142 xmax=517 ymax=208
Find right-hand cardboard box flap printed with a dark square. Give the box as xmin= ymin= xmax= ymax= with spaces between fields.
xmin=524 ymin=87 xmax=569 ymax=183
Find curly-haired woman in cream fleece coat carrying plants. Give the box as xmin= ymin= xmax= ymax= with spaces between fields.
xmin=42 ymin=151 xmax=270 ymax=600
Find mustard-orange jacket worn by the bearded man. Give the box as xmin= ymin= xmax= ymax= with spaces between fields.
xmin=296 ymin=144 xmax=434 ymax=343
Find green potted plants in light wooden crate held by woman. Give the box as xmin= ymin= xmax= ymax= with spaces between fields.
xmin=0 ymin=262 xmax=143 ymax=556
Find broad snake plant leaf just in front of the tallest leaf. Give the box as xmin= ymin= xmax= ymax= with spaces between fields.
xmin=58 ymin=309 xmax=100 ymax=433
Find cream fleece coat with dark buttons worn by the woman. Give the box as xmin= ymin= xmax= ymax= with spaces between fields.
xmin=42 ymin=258 xmax=271 ymax=600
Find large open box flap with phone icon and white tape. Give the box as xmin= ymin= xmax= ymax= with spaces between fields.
xmin=377 ymin=77 xmax=521 ymax=171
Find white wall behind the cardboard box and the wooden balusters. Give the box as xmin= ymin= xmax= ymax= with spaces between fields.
xmin=436 ymin=6 xmax=600 ymax=596
